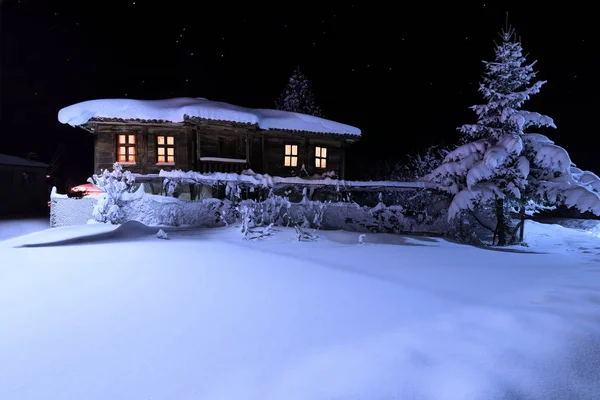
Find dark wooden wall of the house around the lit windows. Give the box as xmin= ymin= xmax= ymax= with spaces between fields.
xmin=94 ymin=119 xmax=352 ymax=179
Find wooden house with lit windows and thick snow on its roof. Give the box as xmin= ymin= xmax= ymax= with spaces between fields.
xmin=59 ymin=98 xmax=360 ymax=179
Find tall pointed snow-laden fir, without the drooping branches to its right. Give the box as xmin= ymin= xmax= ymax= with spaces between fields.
xmin=423 ymin=29 xmax=556 ymax=245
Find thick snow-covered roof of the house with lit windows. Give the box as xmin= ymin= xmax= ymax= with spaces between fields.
xmin=58 ymin=97 xmax=361 ymax=136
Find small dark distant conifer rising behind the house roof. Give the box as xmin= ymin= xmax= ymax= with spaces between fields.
xmin=275 ymin=66 xmax=322 ymax=117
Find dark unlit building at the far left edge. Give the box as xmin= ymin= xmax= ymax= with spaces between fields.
xmin=0 ymin=154 xmax=50 ymax=215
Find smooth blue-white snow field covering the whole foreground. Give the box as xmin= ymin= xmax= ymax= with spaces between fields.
xmin=0 ymin=223 xmax=600 ymax=400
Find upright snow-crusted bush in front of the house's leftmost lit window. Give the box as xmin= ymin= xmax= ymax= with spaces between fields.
xmin=88 ymin=162 xmax=135 ymax=224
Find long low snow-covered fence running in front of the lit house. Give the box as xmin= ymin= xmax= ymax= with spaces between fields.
xmin=51 ymin=186 xmax=447 ymax=234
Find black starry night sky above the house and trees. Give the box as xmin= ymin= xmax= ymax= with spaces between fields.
xmin=0 ymin=0 xmax=600 ymax=181
